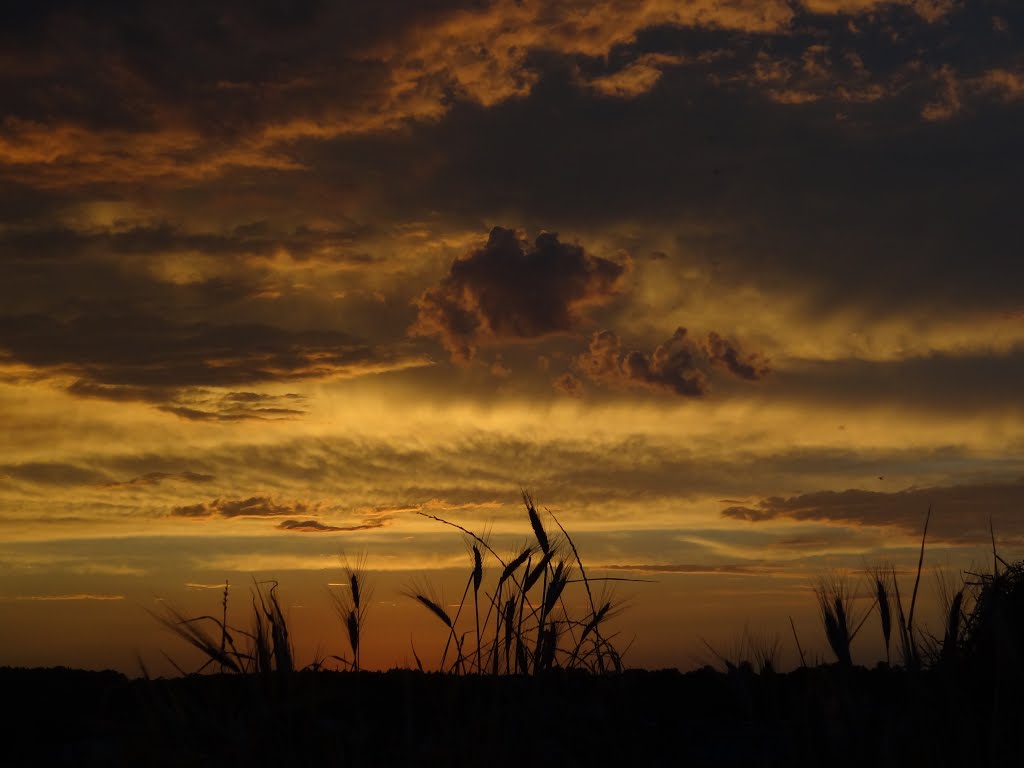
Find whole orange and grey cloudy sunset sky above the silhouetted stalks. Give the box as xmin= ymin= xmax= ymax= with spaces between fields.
xmin=0 ymin=0 xmax=1024 ymax=673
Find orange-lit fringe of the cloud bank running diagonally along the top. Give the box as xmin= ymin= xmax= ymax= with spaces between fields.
xmin=0 ymin=0 xmax=952 ymax=186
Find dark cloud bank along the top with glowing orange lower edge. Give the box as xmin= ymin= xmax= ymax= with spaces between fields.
xmin=0 ymin=0 xmax=995 ymax=198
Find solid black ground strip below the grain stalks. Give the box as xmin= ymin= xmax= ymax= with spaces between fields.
xmin=0 ymin=668 xmax=1024 ymax=768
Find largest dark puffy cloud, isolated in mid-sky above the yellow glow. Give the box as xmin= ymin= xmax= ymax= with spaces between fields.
xmin=410 ymin=226 xmax=628 ymax=361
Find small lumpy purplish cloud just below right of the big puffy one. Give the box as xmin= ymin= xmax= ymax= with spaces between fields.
xmin=573 ymin=328 xmax=710 ymax=397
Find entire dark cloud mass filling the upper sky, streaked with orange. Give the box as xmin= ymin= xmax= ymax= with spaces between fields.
xmin=0 ymin=0 xmax=1024 ymax=327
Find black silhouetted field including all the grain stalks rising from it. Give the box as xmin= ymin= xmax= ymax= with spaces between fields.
xmin=8 ymin=501 xmax=1024 ymax=768
